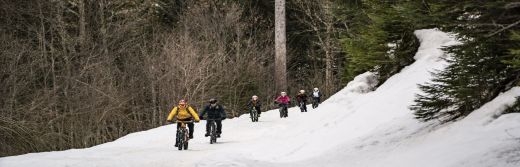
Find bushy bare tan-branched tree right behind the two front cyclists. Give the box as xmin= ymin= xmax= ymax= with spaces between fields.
xmin=164 ymin=3 xmax=272 ymax=116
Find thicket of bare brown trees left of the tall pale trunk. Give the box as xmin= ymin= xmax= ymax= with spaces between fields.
xmin=0 ymin=0 xmax=274 ymax=156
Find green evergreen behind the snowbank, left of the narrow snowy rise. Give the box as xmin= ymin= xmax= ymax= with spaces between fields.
xmin=343 ymin=0 xmax=427 ymax=83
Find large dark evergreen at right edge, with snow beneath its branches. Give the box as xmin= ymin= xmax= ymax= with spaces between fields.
xmin=411 ymin=1 xmax=520 ymax=122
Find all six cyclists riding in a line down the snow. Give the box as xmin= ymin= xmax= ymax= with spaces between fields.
xmin=167 ymin=88 xmax=322 ymax=147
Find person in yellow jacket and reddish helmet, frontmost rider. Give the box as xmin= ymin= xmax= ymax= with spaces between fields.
xmin=167 ymin=99 xmax=200 ymax=139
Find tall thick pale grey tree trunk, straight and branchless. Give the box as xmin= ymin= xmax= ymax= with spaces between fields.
xmin=274 ymin=0 xmax=287 ymax=91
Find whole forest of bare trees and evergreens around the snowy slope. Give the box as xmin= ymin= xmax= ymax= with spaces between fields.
xmin=0 ymin=0 xmax=520 ymax=156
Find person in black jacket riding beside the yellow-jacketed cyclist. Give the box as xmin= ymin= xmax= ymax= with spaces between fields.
xmin=199 ymin=99 xmax=226 ymax=137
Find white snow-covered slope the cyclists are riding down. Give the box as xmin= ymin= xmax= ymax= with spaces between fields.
xmin=0 ymin=29 xmax=520 ymax=167
